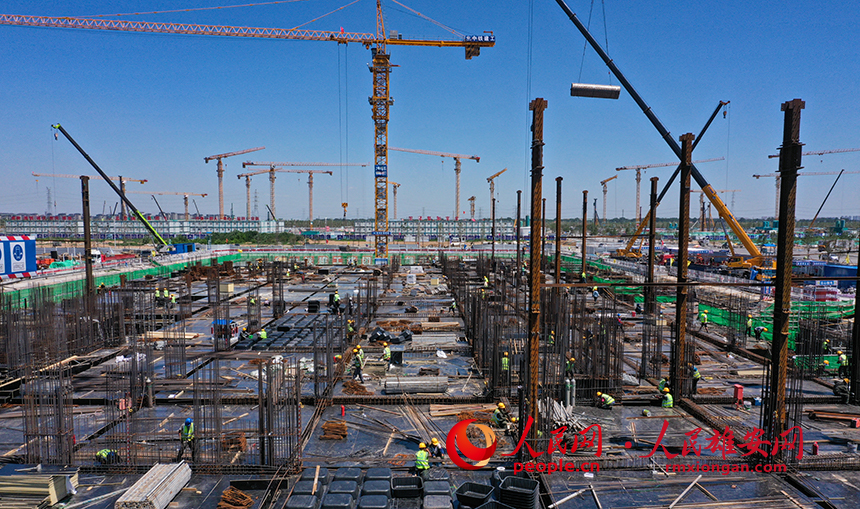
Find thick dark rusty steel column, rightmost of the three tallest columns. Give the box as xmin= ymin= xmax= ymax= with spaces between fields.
xmin=764 ymin=99 xmax=805 ymax=444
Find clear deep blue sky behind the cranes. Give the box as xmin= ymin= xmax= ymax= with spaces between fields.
xmin=0 ymin=0 xmax=860 ymax=218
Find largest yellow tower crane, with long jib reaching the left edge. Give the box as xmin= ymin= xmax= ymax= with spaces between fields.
xmin=0 ymin=0 xmax=496 ymax=263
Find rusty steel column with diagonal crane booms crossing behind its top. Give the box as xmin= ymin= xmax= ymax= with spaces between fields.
xmin=670 ymin=133 xmax=695 ymax=398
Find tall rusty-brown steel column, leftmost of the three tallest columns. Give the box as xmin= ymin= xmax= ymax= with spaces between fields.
xmin=525 ymin=98 xmax=547 ymax=438
